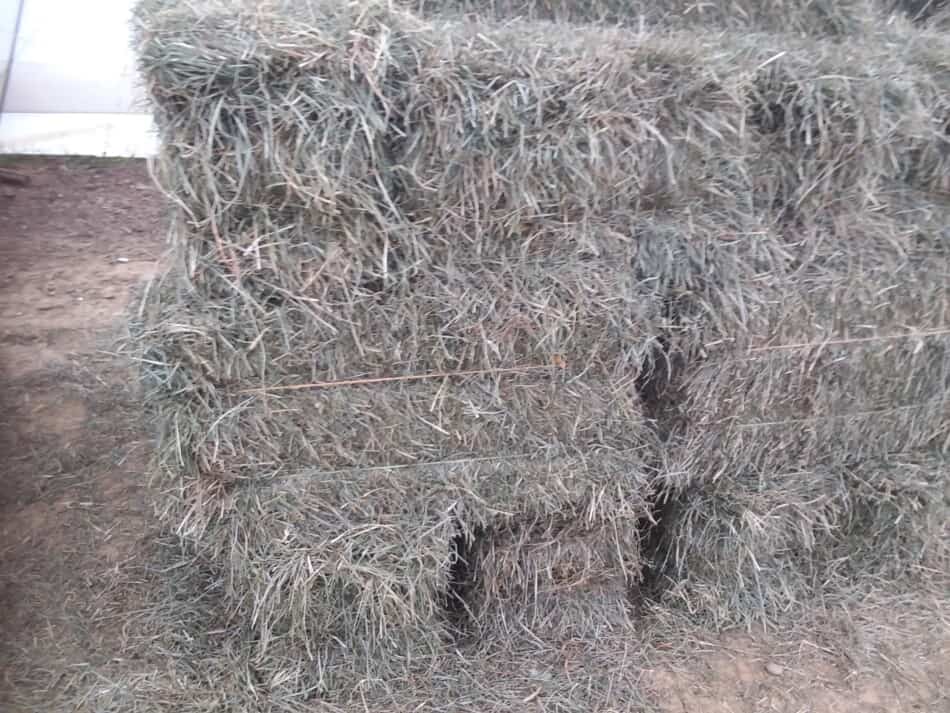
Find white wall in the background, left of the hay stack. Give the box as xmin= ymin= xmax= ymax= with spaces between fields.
xmin=0 ymin=0 xmax=155 ymax=156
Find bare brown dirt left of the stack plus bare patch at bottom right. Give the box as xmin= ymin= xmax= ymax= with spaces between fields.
xmin=0 ymin=159 xmax=950 ymax=713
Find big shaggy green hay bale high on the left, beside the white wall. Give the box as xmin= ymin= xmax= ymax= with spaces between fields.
xmin=140 ymin=2 xmax=742 ymax=264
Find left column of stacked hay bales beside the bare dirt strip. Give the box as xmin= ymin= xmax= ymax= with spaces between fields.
xmin=134 ymin=2 xmax=672 ymax=672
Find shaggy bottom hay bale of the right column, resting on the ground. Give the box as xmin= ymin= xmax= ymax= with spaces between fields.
xmin=658 ymin=453 xmax=950 ymax=626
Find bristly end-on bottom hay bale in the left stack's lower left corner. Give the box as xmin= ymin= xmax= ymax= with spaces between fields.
xmin=208 ymin=477 xmax=455 ymax=650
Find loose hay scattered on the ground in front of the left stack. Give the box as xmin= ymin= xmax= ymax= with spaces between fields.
xmin=40 ymin=540 xmax=651 ymax=713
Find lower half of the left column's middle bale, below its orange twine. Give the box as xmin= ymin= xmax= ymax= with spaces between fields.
xmin=145 ymin=350 xmax=656 ymax=483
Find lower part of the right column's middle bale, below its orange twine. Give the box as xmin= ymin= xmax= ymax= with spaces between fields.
xmin=682 ymin=334 xmax=950 ymax=480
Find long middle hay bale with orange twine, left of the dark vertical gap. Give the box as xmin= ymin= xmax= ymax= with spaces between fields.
xmin=141 ymin=239 xmax=657 ymax=480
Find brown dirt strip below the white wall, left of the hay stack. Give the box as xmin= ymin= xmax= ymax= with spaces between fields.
xmin=0 ymin=159 xmax=163 ymax=711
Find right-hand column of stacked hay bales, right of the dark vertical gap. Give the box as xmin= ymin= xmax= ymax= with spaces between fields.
xmin=659 ymin=32 xmax=950 ymax=623
